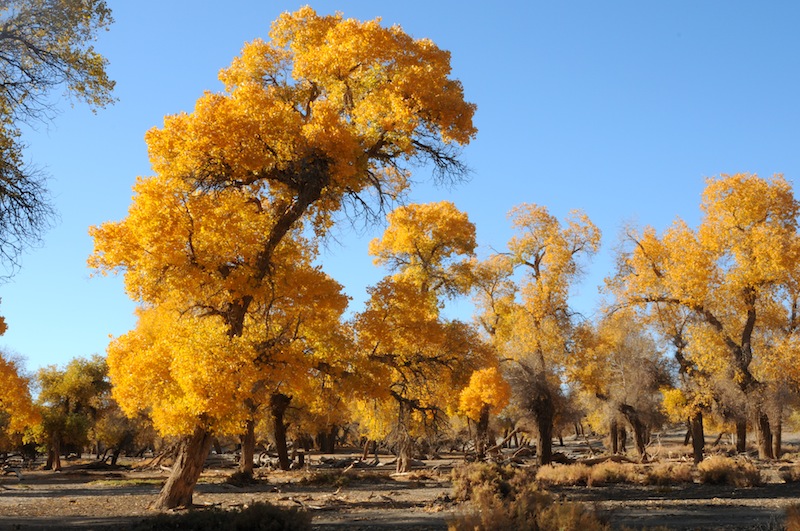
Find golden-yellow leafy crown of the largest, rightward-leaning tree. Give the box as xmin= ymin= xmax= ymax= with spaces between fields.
xmin=89 ymin=7 xmax=476 ymax=440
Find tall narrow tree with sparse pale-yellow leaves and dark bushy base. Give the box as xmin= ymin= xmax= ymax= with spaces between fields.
xmin=476 ymin=204 xmax=600 ymax=464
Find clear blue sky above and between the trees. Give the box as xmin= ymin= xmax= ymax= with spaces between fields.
xmin=0 ymin=0 xmax=800 ymax=370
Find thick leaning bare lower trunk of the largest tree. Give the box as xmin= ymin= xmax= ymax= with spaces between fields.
xmin=153 ymin=427 xmax=214 ymax=510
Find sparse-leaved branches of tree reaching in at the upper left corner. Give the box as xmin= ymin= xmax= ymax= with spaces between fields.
xmin=0 ymin=0 xmax=114 ymax=273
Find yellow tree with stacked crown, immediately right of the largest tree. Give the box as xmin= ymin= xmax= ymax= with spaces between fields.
xmin=353 ymin=201 xmax=490 ymax=472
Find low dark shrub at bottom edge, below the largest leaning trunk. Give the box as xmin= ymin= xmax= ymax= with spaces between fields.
xmin=127 ymin=502 xmax=311 ymax=531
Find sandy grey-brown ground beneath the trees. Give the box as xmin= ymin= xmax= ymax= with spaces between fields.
xmin=0 ymin=430 xmax=800 ymax=531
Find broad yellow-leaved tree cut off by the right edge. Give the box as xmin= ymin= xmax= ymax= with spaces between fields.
xmin=610 ymin=174 xmax=800 ymax=458
